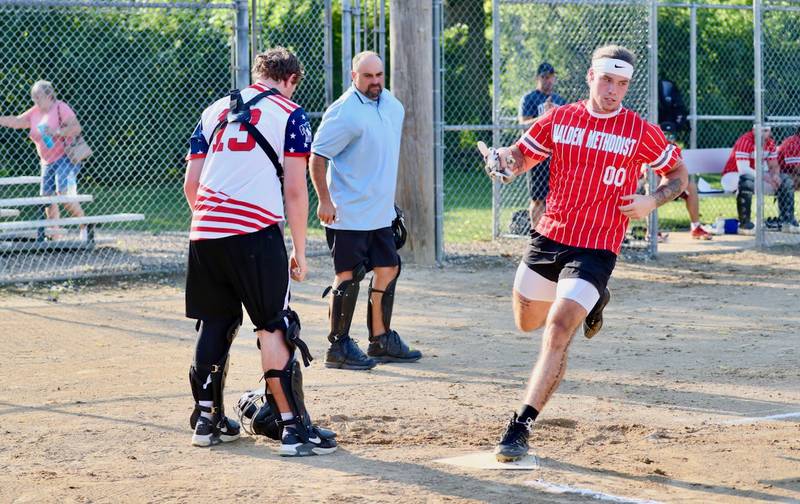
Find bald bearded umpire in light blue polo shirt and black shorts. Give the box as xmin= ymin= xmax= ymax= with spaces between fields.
xmin=310 ymin=51 xmax=422 ymax=369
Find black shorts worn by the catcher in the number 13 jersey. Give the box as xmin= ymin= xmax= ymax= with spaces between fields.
xmin=186 ymin=225 xmax=289 ymax=331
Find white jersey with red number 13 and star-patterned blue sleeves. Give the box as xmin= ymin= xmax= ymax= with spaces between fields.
xmin=186 ymin=83 xmax=312 ymax=241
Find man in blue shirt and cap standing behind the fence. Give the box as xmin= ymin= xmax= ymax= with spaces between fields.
xmin=519 ymin=62 xmax=566 ymax=229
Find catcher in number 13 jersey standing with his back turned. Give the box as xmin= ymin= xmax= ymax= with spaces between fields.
xmin=184 ymin=47 xmax=336 ymax=456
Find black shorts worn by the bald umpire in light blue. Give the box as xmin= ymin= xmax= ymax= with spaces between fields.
xmin=325 ymin=227 xmax=400 ymax=273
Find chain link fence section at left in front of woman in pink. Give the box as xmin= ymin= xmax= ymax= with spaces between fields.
xmin=0 ymin=0 xmax=241 ymax=283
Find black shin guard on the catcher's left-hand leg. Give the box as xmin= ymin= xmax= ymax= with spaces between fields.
xmin=189 ymin=318 xmax=242 ymax=429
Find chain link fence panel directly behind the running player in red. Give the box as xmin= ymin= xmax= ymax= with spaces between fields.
xmin=442 ymin=0 xmax=651 ymax=250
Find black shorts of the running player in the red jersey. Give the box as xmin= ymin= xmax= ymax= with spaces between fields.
xmin=522 ymin=231 xmax=617 ymax=295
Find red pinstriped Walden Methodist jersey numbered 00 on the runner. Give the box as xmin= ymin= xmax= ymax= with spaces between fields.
xmin=517 ymin=102 xmax=679 ymax=254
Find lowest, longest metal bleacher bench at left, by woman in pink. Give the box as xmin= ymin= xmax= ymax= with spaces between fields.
xmin=0 ymin=213 xmax=144 ymax=252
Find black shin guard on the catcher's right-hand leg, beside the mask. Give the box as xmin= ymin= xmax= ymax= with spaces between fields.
xmin=259 ymin=356 xmax=313 ymax=441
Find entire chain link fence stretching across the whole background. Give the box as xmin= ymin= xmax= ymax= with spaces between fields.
xmin=0 ymin=0 xmax=800 ymax=283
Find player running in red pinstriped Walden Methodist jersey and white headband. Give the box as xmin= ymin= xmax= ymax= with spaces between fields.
xmin=488 ymin=46 xmax=687 ymax=462
